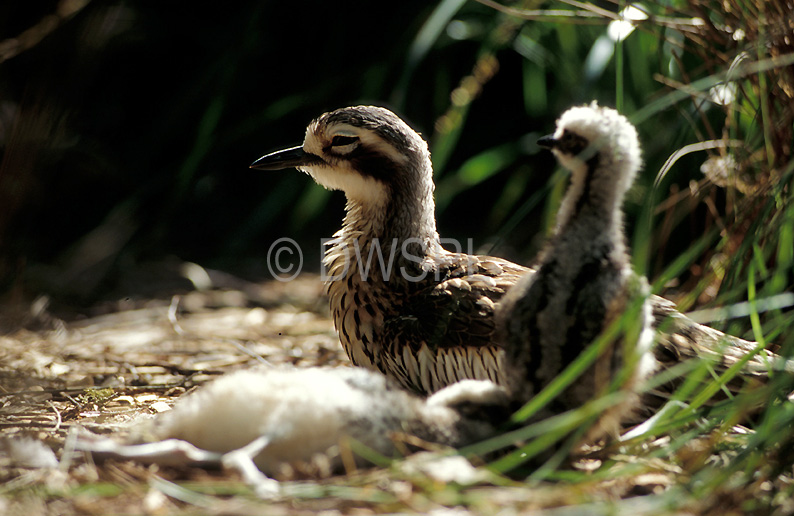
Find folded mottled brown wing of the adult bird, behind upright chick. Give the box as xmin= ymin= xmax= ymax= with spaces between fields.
xmin=383 ymin=253 xmax=530 ymax=394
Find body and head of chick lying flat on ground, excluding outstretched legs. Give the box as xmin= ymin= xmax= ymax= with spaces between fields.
xmin=148 ymin=367 xmax=507 ymax=474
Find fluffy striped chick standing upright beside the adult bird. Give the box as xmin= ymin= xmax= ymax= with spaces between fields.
xmin=496 ymin=103 xmax=656 ymax=439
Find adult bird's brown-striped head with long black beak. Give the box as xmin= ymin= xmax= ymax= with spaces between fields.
xmin=251 ymin=106 xmax=433 ymax=206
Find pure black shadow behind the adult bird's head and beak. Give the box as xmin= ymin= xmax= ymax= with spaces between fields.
xmin=0 ymin=1 xmax=553 ymax=301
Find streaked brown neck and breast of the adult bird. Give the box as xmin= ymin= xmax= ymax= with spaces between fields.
xmin=324 ymin=159 xmax=443 ymax=372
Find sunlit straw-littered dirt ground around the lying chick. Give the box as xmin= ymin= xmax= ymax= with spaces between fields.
xmin=0 ymin=271 xmax=784 ymax=516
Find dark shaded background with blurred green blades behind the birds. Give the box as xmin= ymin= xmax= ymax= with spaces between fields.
xmin=0 ymin=0 xmax=792 ymax=322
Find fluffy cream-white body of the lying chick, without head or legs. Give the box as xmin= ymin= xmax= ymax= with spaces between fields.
xmin=152 ymin=368 xmax=446 ymax=473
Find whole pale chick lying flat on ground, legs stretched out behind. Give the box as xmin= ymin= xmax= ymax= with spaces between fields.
xmin=78 ymin=367 xmax=510 ymax=494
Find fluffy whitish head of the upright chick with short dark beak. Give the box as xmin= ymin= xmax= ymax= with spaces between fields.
xmin=538 ymin=102 xmax=641 ymax=201
